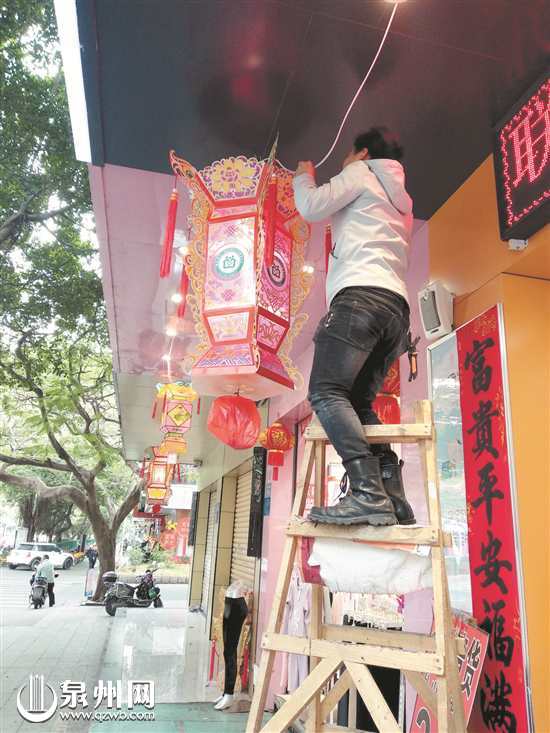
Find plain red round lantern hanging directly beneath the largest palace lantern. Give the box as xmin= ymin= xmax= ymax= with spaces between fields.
xmin=207 ymin=395 xmax=262 ymax=450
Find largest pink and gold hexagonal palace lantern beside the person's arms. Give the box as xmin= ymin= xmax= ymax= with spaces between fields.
xmin=170 ymin=144 xmax=309 ymax=400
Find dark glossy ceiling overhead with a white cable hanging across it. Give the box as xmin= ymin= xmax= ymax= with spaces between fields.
xmin=77 ymin=0 xmax=550 ymax=219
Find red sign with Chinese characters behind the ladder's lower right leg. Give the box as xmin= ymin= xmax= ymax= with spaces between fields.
xmin=409 ymin=616 xmax=487 ymax=733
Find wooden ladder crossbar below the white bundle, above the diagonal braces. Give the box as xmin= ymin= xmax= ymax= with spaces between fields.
xmin=262 ymin=632 xmax=443 ymax=675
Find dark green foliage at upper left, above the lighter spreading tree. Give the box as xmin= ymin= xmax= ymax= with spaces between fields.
xmin=0 ymin=0 xmax=106 ymax=344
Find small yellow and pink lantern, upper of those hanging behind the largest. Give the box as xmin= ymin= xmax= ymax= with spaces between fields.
xmin=155 ymin=383 xmax=197 ymax=455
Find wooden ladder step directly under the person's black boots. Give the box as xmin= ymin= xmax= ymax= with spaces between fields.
xmin=286 ymin=517 xmax=452 ymax=547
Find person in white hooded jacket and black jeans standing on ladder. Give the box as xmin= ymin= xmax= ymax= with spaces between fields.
xmin=293 ymin=127 xmax=415 ymax=525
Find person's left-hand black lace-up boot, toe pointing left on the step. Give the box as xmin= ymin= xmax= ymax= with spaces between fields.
xmin=309 ymin=456 xmax=397 ymax=527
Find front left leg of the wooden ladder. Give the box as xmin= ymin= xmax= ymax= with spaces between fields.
xmin=246 ymin=443 xmax=315 ymax=733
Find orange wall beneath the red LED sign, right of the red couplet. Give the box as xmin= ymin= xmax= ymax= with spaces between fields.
xmin=428 ymin=152 xmax=550 ymax=733
